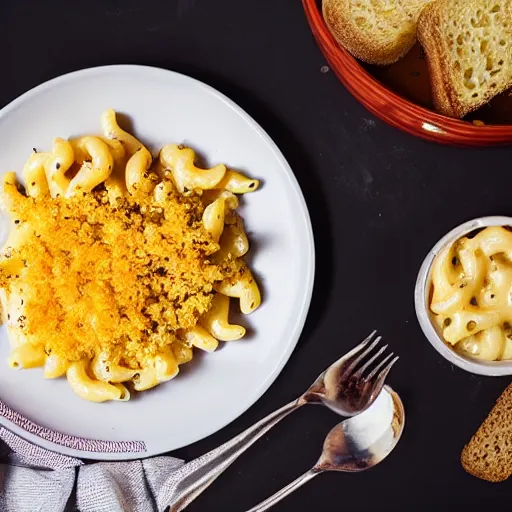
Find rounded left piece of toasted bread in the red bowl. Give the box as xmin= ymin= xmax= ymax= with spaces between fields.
xmin=322 ymin=0 xmax=432 ymax=65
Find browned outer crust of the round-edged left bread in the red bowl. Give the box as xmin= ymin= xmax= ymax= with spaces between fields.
xmin=322 ymin=0 xmax=431 ymax=65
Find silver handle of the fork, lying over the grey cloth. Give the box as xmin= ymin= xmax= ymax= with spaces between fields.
xmin=166 ymin=399 xmax=306 ymax=512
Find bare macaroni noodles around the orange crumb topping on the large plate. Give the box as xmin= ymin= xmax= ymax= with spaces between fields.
xmin=0 ymin=110 xmax=262 ymax=402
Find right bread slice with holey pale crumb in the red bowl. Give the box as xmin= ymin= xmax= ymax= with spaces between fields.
xmin=418 ymin=0 xmax=512 ymax=117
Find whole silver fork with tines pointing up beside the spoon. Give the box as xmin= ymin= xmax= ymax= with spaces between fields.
xmin=166 ymin=331 xmax=398 ymax=512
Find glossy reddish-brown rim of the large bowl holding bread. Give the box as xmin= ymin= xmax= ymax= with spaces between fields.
xmin=302 ymin=0 xmax=512 ymax=146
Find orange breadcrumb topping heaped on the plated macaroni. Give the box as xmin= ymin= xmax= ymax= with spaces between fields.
xmin=1 ymin=187 xmax=240 ymax=369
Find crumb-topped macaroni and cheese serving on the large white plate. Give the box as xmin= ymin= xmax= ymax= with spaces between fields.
xmin=0 ymin=110 xmax=261 ymax=402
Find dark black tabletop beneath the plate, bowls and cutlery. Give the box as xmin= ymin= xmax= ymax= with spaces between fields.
xmin=0 ymin=0 xmax=512 ymax=512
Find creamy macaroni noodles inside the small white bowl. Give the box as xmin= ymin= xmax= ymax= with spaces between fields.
xmin=430 ymin=227 xmax=512 ymax=361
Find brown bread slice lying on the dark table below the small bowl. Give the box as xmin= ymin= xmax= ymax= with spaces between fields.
xmin=461 ymin=384 xmax=512 ymax=482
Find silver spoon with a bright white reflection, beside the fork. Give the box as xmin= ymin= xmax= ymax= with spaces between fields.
xmin=247 ymin=386 xmax=405 ymax=512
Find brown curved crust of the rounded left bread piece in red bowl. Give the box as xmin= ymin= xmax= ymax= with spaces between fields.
xmin=322 ymin=0 xmax=420 ymax=66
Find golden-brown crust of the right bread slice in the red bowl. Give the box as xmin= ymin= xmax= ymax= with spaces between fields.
xmin=418 ymin=0 xmax=512 ymax=118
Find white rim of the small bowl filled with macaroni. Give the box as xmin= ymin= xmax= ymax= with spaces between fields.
xmin=414 ymin=215 xmax=512 ymax=377
